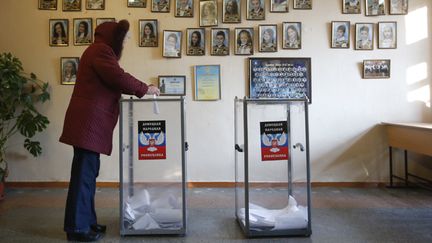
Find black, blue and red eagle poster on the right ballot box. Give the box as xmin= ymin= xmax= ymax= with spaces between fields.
xmin=260 ymin=121 xmax=288 ymax=161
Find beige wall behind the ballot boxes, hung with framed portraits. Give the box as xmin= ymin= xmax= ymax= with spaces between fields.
xmin=0 ymin=0 xmax=432 ymax=181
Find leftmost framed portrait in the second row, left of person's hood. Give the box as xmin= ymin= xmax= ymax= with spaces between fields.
xmin=49 ymin=19 xmax=69 ymax=46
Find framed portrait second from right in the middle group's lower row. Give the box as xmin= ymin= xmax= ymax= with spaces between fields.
xmin=258 ymin=24 xmax=278 ymax=52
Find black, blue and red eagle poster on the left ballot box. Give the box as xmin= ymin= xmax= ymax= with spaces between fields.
xmin=138 ymin=121 xmax=166 ymax=160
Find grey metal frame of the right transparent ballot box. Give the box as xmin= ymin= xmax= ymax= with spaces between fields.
xmin=234 ymin=97 xmax=312 ymax=238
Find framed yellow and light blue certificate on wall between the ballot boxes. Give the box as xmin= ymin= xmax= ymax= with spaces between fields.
xmin=194 ymin=65 xmax=221 ymax=101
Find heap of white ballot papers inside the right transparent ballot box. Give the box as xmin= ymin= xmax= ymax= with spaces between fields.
xmin=240 ymin=196 xmax=308 ymax=231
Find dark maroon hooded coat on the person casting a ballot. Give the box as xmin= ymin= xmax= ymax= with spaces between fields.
xmin=60 ymin=20 xmax=148 ymax=155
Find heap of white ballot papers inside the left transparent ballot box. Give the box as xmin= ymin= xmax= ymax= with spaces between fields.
xmin=124 ymin=189 xmax=183 ymax=230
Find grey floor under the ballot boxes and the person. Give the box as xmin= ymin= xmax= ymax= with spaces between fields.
xmin=0 ymin=187 xmax=432 ymax=243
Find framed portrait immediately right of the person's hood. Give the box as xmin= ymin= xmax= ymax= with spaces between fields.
xmin=138 ymin=19 xmax=158 ymax=47
